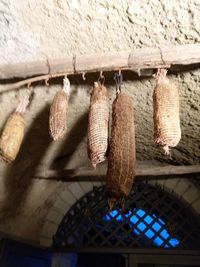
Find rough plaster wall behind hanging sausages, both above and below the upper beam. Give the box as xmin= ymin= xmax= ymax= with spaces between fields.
xmin=0 ymin=0 xmax=200 ymax=246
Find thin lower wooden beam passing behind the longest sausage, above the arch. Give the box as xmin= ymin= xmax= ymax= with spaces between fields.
xmin=34 ymin=164 xmax=200 ymax=182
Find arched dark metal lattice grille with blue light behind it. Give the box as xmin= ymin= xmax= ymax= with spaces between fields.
xmin=53 ymin=183 xmax=200 ymax=249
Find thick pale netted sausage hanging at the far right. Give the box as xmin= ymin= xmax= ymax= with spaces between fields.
xmin=153 ymin=69 xmax=181 ymax=153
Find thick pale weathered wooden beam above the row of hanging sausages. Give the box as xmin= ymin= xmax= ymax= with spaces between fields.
xmin=0 ymin=44 xmax=200 ymax=80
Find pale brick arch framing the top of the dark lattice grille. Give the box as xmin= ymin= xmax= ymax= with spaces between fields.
xmin=39 ymin=178 xmax=200 ymax=247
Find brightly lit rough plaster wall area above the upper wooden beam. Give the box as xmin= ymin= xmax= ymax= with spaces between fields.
xmin=1 ymin=0 xmax=200 ymax=61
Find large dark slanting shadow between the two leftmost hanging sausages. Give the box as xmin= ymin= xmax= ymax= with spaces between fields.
xmin=0 ymin=103 xmax=51 ymax=222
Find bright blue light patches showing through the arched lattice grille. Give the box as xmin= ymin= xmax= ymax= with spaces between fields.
xmin=103 ymin=208 xmax=180 ymax=248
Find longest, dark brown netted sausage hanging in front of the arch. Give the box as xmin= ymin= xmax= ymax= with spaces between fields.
xmin=106 ymin=93 xmax=136 ymax=207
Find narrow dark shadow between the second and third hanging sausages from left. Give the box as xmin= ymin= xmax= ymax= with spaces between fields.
xmin=50 ymin=112 xmax=88 ymax=170
